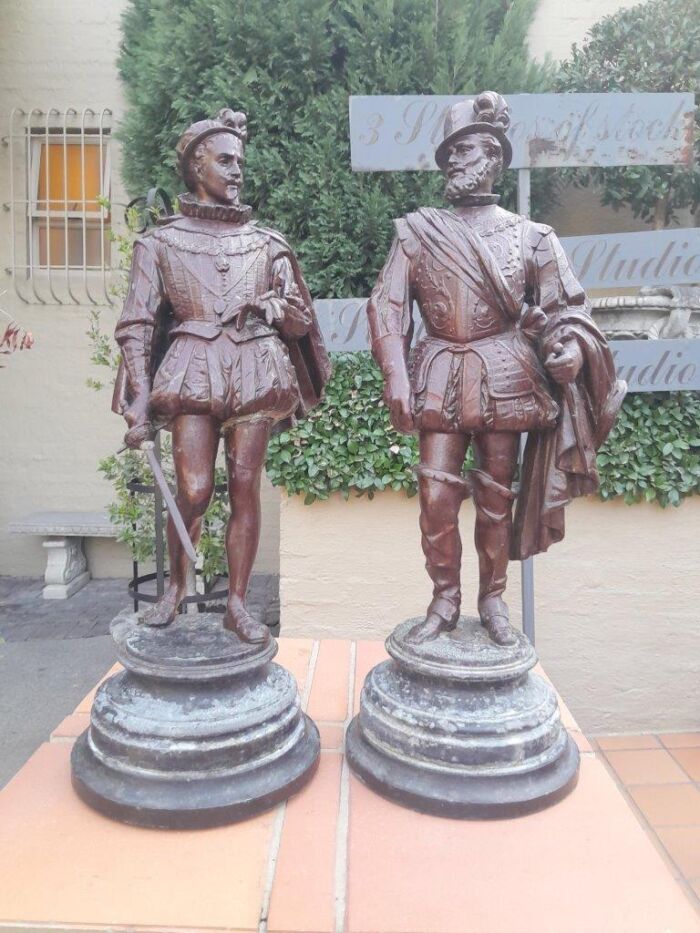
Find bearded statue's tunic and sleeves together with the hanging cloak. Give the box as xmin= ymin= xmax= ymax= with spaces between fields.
xmin=367 ymin=205 xmax=626 ymax=558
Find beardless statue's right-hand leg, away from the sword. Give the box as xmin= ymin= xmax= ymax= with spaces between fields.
xmin=224 ymin=418 xmax=272 ymax=643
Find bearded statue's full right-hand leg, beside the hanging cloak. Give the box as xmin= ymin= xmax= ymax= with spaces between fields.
xmin=470 ymin=431 xmax=520 ymax=645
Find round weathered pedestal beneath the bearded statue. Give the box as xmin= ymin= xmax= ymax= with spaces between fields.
xmin=346 ymin=617 xmax=579 ymax=819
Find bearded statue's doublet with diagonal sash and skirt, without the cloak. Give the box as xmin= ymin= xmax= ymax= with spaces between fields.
xmin=368 ymin=205 xmax=573 ymax=433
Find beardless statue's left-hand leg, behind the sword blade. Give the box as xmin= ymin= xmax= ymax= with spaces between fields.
xmin=142 ymin=415 xmax=219 ymax=625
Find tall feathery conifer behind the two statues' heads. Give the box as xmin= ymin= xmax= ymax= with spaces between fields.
xmin=119 ymin=0 xmax=550 ymax=298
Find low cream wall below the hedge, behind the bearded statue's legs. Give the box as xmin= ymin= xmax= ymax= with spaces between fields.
xmin=280 ymin=492 xmax=700 ymax=733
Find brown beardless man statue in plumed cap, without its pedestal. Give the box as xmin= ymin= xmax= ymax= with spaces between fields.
xmin=114 ymin=110 xmax=330 ymax=642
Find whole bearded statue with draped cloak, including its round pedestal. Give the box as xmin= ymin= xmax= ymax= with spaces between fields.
xmin=347 ymin=92 xmax=626 ymax=817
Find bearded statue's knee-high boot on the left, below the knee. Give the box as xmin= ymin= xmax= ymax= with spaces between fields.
xmin=406 ymin=463 xmax=467 ymax=645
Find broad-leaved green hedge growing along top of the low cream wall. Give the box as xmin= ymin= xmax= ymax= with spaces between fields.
xmin=267 ymin=353 xmax=700 ymax=506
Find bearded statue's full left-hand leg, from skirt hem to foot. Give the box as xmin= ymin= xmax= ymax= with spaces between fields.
xmin=408 ymin=431 xmax=469 ymax=644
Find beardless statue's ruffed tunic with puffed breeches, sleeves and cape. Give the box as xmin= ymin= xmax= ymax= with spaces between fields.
xmin=116 ymin=195 xmax=330 ymax=428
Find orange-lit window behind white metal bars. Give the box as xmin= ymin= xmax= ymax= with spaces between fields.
xmin=8 ymin=108 xmax=112 ymax=304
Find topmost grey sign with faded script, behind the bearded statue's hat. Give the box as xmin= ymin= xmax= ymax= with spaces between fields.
xmin=350 ymin=92 xmax=695 ymax=172
